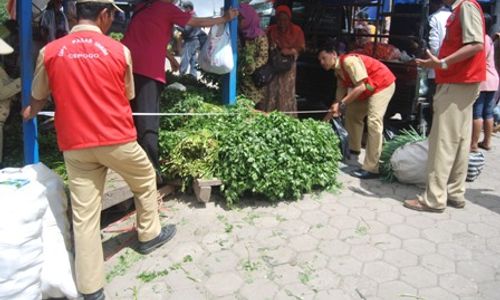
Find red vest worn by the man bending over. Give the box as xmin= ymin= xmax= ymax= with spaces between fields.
xmin=339 ymin=54 xmax=396 ymax=100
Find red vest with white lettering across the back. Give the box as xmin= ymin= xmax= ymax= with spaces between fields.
xmin=44 ymin=31 xmax=137 ymax=151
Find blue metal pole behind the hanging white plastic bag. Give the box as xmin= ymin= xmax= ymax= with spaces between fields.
xmin=222 ymin=0 xmax=239 ymax=105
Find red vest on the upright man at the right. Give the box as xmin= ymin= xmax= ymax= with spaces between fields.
xmin=436 ymin=0 xmax=486 ymax=83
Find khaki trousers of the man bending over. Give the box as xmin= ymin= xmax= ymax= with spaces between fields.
xmin=346 ymin=83 xmax=396 ymax=174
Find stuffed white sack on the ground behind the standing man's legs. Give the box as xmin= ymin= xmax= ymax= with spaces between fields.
xmin=391 ymin=140 xmax=429 ymax=186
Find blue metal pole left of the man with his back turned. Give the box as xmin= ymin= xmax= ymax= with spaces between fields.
xmin=17 ymin=0 xmax=39 ymax=164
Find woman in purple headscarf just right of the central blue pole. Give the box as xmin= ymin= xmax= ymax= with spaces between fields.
xmin=238 ymin=3 xmax=269 ymax=104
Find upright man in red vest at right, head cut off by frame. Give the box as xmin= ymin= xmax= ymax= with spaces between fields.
xmin=404 ymin=0 xmax=486 ymax=212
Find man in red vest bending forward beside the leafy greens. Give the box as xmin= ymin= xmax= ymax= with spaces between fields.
xmin=318 ymin=43 xmax=396 ymax=179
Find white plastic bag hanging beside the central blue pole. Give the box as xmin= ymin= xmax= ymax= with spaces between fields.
xmin=198 ymin=24 xmax=234 ymax=74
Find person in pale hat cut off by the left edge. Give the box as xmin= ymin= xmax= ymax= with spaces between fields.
xmin=0 ymin=38 xmax=21 ymax=169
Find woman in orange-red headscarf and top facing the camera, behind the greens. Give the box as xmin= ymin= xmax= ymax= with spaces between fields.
xmin=264 ymin=5 xmax=305 ymax=115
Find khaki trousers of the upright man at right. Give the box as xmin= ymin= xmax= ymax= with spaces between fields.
xmin=419 ymin=83 xmax=479 ymax=209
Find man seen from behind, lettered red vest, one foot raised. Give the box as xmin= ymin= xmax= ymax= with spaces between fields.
xmin=22 ymin=0 xmax=175 ymax=300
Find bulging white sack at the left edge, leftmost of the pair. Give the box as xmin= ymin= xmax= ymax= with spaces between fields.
xmin=0 ymin=168 xmax=47 ymax=300
